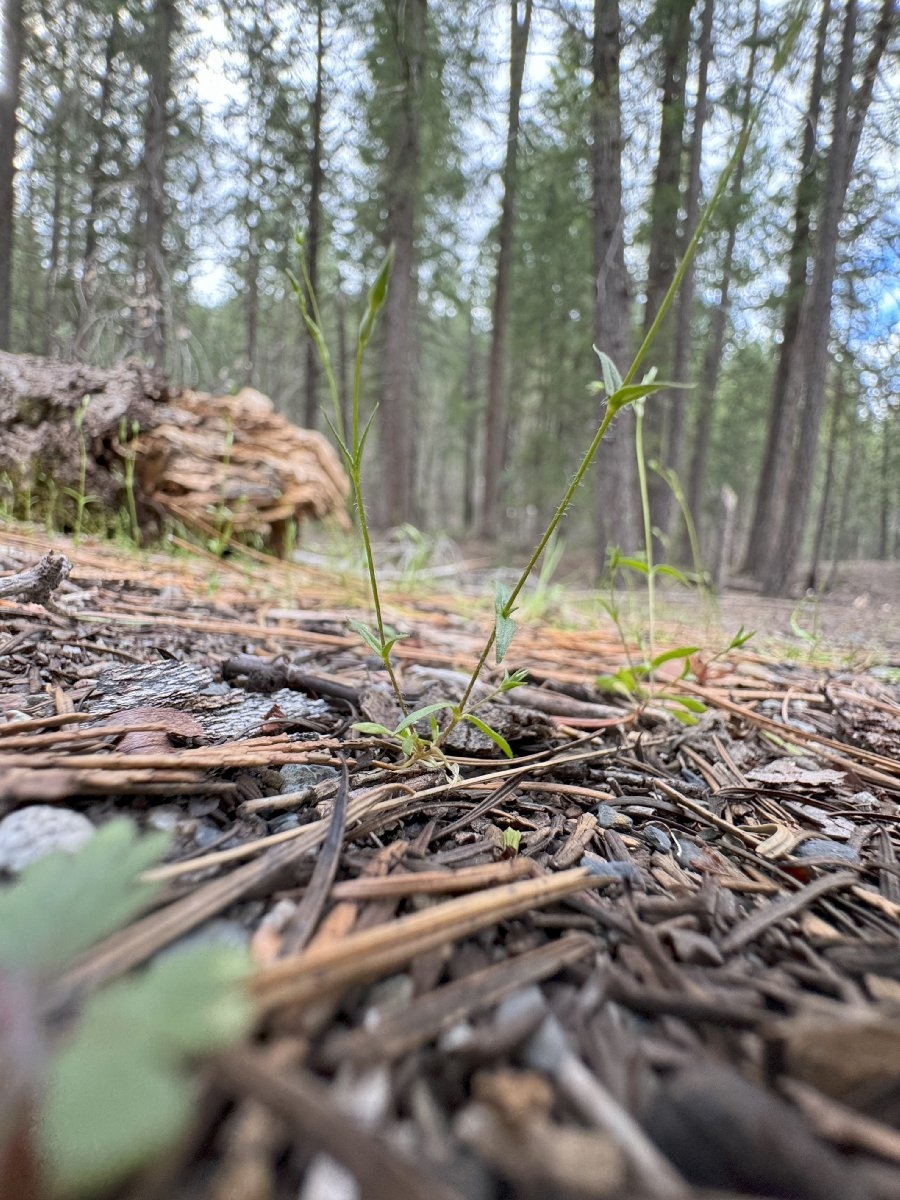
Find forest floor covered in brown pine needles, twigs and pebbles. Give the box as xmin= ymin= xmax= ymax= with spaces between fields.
xmin=0 ymin=528 xmax=900 ymax=1200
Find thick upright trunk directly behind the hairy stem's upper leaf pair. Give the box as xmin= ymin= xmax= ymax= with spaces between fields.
xmin=590 ymin=0 xmax=641 ymax=556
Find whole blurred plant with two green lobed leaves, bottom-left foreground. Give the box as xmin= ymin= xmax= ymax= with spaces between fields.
xmin=0 ymin=820 xmax=252 ymax=1200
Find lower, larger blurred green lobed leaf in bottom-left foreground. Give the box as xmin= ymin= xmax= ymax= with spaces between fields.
xmin=38 ymin=948 xmax=252 ymax=1198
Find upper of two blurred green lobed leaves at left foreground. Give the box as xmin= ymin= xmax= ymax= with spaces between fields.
xmin=0 ymin=818 xmax=168 ymax=971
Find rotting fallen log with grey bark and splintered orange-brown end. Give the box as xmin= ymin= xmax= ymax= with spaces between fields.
xmin=0 ymin=354 xmax=349 ymax=554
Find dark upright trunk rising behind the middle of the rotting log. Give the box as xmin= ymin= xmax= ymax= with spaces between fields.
xmin=144 ymin=0 xmax=178 ymax=367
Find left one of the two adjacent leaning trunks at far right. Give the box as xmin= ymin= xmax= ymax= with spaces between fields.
xmin=744 ymin=0 xmax=832 ymax=575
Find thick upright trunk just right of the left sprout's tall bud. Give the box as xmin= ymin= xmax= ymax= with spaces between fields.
xmin=380 ymin=0 xmax=427 ymax=524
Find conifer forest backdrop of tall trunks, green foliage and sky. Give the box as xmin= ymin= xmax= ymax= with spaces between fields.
xmin=0 ymin=0 xmax=900 ymax=594
